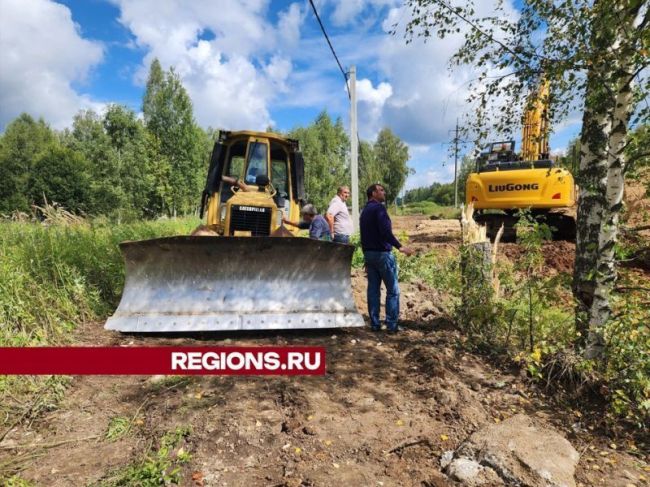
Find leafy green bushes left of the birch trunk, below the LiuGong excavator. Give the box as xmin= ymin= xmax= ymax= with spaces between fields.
xmin=449 ymin=212 xmax=576 ymax=362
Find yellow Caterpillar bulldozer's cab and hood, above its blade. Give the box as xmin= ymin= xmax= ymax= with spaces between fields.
xmin=201 ymin=131 xmax=304 ymax=236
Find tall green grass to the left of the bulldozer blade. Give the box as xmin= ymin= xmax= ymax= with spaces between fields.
xmin=0 ymin=218 xmax=198 ymax=346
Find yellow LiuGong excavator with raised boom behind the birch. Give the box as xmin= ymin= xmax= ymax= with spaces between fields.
xmin=465 ymin=81 xmax=576 ymax=241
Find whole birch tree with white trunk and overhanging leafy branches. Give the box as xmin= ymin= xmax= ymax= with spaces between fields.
xmin=395 ymin=0 xmax=650 ymax=358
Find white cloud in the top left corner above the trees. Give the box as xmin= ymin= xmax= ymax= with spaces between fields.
xmin=0 ymin=0 xmax=103 ymax=129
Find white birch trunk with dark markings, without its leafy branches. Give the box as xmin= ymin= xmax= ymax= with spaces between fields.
xmin=573 ymin=3 xmax=639 ymax=358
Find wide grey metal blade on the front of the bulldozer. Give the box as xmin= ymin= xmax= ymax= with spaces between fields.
xmin=106 ymin=236 xmax=364 ymax=333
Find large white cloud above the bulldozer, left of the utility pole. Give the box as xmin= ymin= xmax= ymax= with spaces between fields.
xmin=117 ymin=0 xmax=304 ymax=129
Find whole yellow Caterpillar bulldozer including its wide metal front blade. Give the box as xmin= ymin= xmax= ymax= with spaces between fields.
xmin=106 ymin=131 xmax=363 ymax=333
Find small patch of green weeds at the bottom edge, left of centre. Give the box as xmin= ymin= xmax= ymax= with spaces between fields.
xmin=99 ymin=427 xmax=192 ymax=487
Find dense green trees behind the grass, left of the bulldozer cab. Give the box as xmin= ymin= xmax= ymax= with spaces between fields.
xmin=0 ymin=61 xmax=214 ymax=223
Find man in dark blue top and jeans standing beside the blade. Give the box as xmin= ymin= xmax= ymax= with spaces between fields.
xmin=359 ymin=184 xmax=413 ymax=333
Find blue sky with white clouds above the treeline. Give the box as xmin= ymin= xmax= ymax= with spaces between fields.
xmin=0 ymin=0 xmax=579 ymax=188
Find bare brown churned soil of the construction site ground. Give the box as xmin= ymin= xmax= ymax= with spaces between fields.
xmin=0 ymin=216 xmax=650 ymax=487
